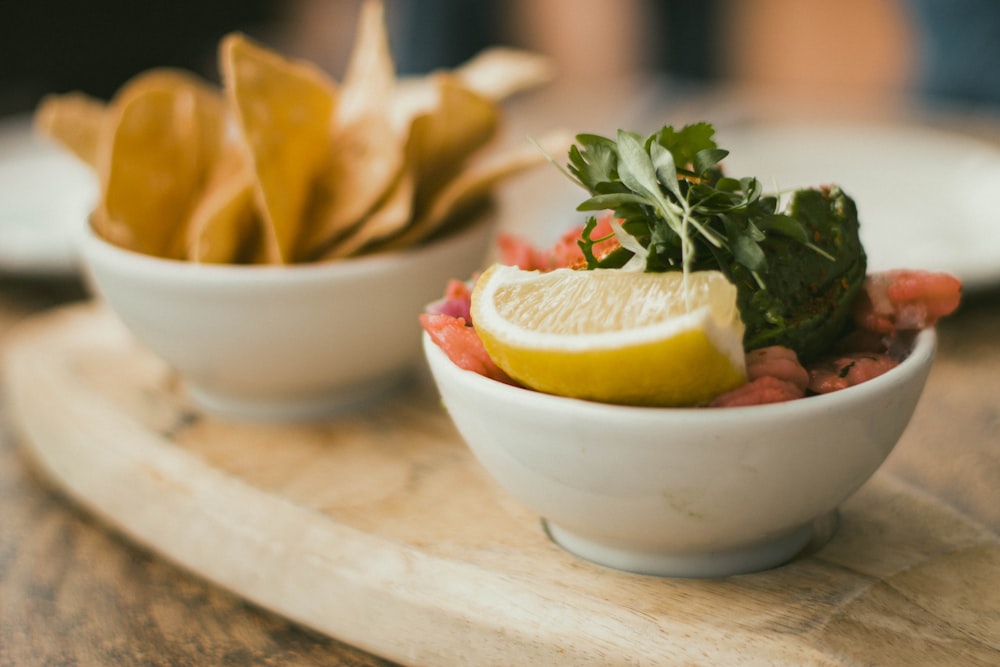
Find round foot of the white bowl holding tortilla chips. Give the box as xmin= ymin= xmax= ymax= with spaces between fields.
xmin=187 ymin=374 xmax=409 ymax=422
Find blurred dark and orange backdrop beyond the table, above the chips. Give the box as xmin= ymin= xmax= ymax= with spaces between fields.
xmin=0 ymin=0 xmax=1000 ymax=114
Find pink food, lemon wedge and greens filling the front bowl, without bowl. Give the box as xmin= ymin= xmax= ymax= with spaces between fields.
xmin=422 ymin=123 xmax=961 ymax=407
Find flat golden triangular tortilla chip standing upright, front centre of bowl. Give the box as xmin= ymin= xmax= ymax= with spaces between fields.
xmin=220 ymin=34 xmax=338 ymax=264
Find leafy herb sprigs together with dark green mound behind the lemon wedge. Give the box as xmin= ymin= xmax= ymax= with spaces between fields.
xmin=540 ymin=123 xmax=866 ymax=360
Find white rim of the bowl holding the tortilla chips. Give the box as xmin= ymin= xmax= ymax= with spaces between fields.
xmin=80 ymin=207 xmax=496 ymax=282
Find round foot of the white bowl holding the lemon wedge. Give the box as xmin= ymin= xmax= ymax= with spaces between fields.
xmin=543 ymin=521 xmax=829 ymax=578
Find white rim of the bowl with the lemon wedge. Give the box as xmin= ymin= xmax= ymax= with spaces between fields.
xmin=422 ymin=327 xmax=937 ymax=422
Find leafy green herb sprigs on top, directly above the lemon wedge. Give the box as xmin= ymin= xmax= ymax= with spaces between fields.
xmin=548 ymin=123 xmax=833 ymax=289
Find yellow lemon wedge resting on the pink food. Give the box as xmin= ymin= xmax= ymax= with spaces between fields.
xmin=471 ymin=264 xmax=746 ymax=406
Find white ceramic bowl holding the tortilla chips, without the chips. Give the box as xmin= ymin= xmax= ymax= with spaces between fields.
xmin=81 ymin=213 xmax=494 ymax=420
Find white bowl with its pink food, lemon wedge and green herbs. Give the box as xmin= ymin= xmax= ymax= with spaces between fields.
xmin=421 ymin=124 xmax=961 ymax=576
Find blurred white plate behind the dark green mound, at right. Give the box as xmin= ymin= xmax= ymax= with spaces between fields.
xmin=716 ymin=125 xmax=1000 ymax=288
